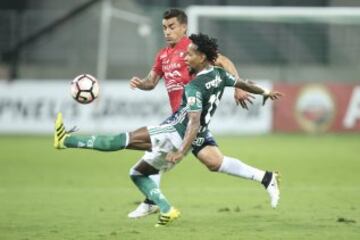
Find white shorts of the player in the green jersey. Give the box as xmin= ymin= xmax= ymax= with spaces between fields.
xmin=142 ymin=124 xmax=183 ymax=171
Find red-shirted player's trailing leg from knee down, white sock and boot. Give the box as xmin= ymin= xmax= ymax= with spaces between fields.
xmin=197 ymin=146 xmax=280 ymax=208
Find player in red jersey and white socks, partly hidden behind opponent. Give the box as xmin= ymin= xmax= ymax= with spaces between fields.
xmin=128 ymin=9 xmax=274 ymax=218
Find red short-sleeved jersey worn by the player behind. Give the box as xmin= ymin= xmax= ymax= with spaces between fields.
xmin=153 ymin=37 xmax=192 ymax=112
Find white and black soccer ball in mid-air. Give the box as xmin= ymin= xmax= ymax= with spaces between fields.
xmin=70 ymin=74 xmax=99 ymax=104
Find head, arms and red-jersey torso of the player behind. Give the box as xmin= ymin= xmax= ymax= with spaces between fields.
xmin=130 ymin=9 xmax=253 ymax=112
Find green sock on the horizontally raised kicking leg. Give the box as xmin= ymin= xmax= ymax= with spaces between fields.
xmin=64 ymin=133 xmax=128 ymax=151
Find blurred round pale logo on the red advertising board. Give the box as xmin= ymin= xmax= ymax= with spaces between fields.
xmin=295 ymin=85 xmax=335 ymax=133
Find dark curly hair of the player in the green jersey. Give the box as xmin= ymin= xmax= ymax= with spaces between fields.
xmin=189 ymin=33 xmax=218 ymax=62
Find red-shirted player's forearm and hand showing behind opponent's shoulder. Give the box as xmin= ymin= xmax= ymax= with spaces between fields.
xmin=215 ymin=54 xmax=255 ymax=109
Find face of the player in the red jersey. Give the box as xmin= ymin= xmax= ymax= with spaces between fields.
xmin=162 ymin=17 xmax=187 ymax=46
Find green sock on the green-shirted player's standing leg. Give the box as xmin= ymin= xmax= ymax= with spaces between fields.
xmin=131 ymin=175 xmax=171 ymax=213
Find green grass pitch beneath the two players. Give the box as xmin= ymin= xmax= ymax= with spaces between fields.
xmin=0 ymin=135 xmax=360 ymax=240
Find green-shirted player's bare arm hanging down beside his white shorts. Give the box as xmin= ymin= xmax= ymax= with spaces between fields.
xmin=166 ymin=111 xmax=201 ymax=163
